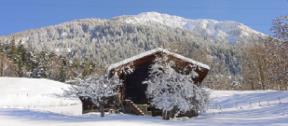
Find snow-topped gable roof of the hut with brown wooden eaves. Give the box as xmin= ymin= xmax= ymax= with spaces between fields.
xmin=108 ymin=48 xmax=210 ymax=84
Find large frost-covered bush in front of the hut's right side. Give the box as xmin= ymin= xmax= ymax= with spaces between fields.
xmin=143 ymin=56 xmax=208 ymax=119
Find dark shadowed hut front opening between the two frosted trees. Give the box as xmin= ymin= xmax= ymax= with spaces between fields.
xmin=124 ymin=64 xmax=150 ymax=104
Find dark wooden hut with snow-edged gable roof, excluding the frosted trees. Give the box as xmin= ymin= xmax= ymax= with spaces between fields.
xmin=108 ymin=48 xmax=210 ymax=115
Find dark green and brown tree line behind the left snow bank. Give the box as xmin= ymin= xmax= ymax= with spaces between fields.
xmin=0 ymin=38 xmax=102 ymax=82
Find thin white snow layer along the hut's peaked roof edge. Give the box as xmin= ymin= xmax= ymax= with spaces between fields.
xmin=108 ymin=48 xmax=210 ymax=71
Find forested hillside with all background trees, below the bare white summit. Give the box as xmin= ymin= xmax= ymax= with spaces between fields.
xmin=0 ymin=12 xmax=287 ymax=89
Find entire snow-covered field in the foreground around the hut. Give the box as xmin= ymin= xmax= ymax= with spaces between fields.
xmin=0 ymin=77 xmax=288 ymax=126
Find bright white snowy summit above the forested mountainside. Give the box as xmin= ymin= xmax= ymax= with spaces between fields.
xmin=113 ymin=12 xmax=265 ymax=43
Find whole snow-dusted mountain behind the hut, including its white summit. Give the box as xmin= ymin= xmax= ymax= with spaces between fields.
xmin=0 ymin=12 xmax=265 ymax=80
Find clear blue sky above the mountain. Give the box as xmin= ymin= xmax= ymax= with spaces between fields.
xmin=0 ymin=0 xmax=288 ymax=35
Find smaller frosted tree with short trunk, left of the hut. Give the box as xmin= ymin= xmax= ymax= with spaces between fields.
xmin=68 ymin=75 xmax=122 ymax=117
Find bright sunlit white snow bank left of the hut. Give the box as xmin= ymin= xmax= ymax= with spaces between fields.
xmin=0 ymin=77 xmax=81 ymax=114
